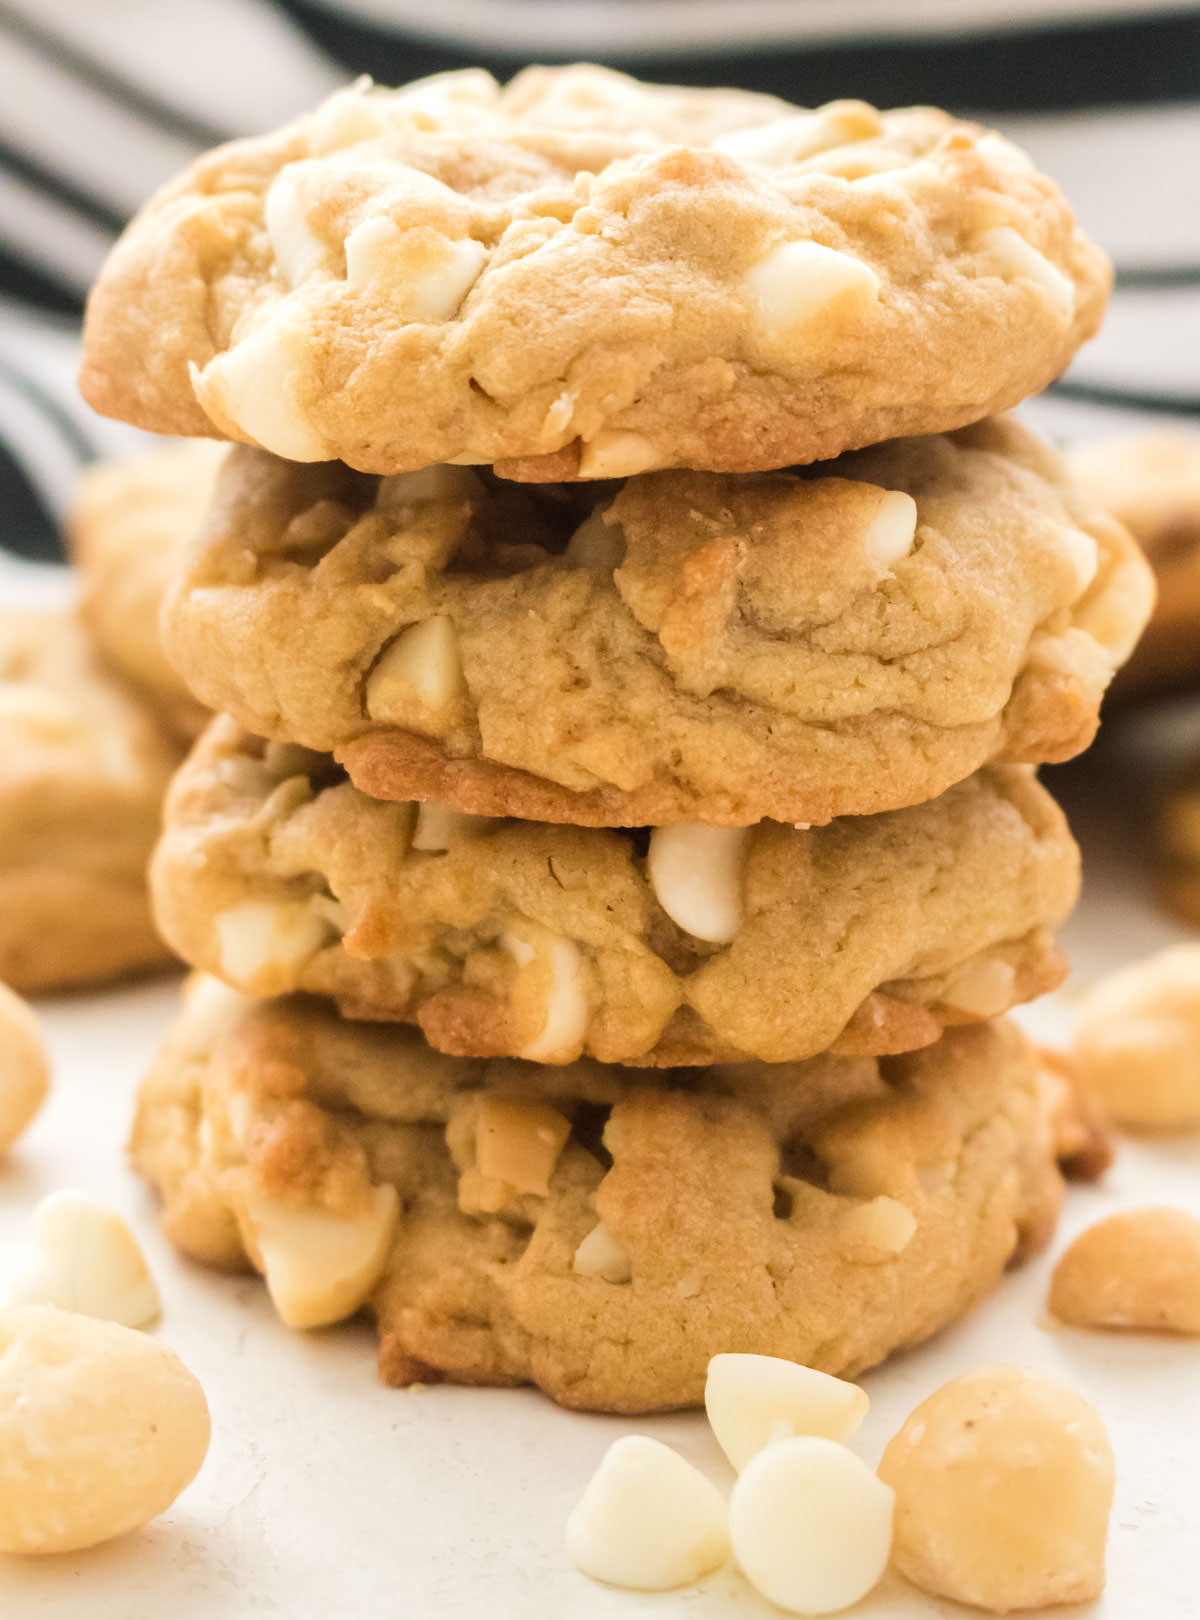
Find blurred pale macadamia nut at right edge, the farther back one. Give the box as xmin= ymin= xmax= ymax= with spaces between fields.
xmin=1075 ymin=944 xmax=1200 ymax=1131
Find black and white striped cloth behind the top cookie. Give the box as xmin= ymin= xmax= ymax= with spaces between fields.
xmin=0 ymin=0 xmax=1200 ymax=557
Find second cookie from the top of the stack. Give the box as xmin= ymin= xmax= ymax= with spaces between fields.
xmin=164 ymin=420 xmax=1151 ymax=826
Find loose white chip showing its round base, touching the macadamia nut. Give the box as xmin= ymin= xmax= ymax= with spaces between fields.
xmin=729 ymin=1435 xmax=896 ymax=1615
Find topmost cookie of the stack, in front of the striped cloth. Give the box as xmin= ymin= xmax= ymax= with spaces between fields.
xmin=81 ymin=66 xmax=1109 ymax=481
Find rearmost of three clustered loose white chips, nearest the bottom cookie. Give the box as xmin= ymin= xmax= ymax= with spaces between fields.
xmin=704 ymin=1353 xmax=871 ymax=1473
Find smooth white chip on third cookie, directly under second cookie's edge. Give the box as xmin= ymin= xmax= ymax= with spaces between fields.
xmin=646 ymin=821 xmax=750 ymax=944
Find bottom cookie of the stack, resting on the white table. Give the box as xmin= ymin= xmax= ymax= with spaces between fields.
xmin=133 ymin=982 xmax=1061 ymax=1413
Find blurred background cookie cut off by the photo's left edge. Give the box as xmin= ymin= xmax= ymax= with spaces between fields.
xmin=0 ymin=609 xmax=177 ymax=991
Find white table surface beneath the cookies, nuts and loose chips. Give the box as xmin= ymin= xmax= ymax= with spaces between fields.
xmin=0 ymin=725 xmax=1200 ymax=1620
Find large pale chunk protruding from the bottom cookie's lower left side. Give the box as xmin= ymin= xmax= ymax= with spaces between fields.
xmin=236 ymin=1183 xmax=400 ymax=1328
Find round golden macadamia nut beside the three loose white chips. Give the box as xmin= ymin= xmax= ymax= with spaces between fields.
xmin=879 ymin=1367 xmax=1113 ymax=1614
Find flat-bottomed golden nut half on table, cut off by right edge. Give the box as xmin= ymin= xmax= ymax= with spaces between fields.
xmin=1049 ymin=1209 xmax=1200 ymax=1333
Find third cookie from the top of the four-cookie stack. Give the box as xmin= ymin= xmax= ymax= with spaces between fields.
xmin=152 ymin=719 xmax=1079 ymax=1064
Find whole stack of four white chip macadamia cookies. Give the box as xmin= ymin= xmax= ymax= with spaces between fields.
xmin=83 ymin=68 xmax=1150 ymax=1411
